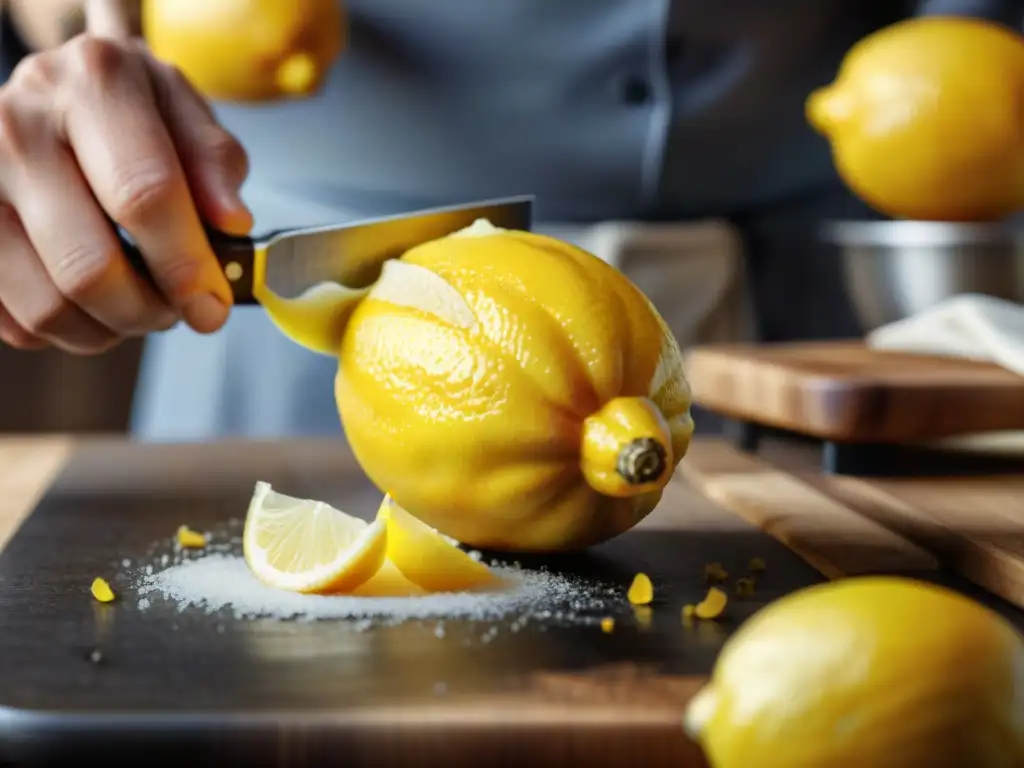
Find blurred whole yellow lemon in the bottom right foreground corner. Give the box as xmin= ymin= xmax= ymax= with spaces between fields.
xmin=686 ymin=578 xmax=1024 ymax=768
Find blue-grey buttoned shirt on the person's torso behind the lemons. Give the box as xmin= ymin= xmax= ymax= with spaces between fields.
xmin=211 ymin=0 xmax=1022 ymax=221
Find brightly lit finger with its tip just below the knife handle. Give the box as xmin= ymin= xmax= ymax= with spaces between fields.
xmin=63 ymin=37 xmax=231 ymax=333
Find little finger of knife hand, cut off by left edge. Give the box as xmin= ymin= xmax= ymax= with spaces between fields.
xmin=0 ymin=199 xmax=118 ymax=354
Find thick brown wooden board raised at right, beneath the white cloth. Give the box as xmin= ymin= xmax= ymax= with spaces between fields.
xmin=687 ymin=342 xmax=1024 ymax=442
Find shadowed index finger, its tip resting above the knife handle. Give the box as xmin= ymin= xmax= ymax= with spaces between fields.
xmin=146 ymin=54 xmax=253 ymax=234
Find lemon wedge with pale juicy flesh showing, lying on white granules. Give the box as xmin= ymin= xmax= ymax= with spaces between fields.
xmin=242 ymin=482 xmax=387 ymax=594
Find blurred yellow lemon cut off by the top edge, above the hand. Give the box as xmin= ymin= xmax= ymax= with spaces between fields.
xmin=142 ymin=0 xmax=346 ymax=101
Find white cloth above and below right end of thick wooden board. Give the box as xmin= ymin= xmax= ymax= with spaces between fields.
xmin=866 ymin=294 xmax=1024 ymax=455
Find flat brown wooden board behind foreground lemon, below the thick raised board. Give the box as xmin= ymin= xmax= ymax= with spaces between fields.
xmin=682 ymin=441 xmax=1024 ymax=608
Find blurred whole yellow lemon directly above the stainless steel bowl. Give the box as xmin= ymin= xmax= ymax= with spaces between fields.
xmin=807 ymin=16 xmax=1024 ymax=221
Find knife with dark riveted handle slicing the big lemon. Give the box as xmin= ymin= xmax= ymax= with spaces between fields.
xmin=116 ymin=196 xmax=534 ymax=305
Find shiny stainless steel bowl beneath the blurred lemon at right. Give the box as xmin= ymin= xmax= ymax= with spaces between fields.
xmin=825 ymin=221 xmax=1024 ymax=332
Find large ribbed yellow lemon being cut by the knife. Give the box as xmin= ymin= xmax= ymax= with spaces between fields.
xmin=336 ymin=222 xmax=693 ymax=551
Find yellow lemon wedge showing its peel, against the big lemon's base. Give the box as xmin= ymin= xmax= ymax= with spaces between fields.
xmin=377 ymin=496 xmax=501 ymax=592
